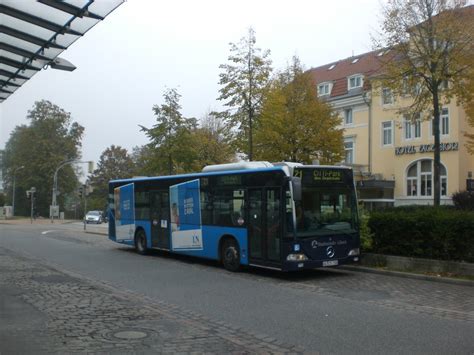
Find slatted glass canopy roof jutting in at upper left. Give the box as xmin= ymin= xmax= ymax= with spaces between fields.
xmin=0 ymin=0 xmax=124 ymax=103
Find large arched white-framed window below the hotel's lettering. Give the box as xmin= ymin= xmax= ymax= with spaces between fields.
xmin=406 ymin=159 xmax=448 ymax=197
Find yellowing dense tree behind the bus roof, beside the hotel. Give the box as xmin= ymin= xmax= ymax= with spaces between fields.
xmin=255 ymin=57 xmax=343 ymax=164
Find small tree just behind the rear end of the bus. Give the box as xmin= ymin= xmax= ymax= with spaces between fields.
xmin=88 ymin=145 xmax=135 ymax=209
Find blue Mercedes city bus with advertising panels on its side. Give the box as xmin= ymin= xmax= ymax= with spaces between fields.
xmin=109 ymin=162 xmax=360 ymax=271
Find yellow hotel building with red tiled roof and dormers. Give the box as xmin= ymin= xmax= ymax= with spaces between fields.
xmin=310 ymin=51 xmax=474 ymax=209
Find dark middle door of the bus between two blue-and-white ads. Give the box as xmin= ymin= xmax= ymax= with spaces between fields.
xmin=150 ymin=191 xmax=170 ymax=250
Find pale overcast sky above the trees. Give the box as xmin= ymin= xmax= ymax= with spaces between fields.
xmin=0 ymin=0 xmax=381 ymax=167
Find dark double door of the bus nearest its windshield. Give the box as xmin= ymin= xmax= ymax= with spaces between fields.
xmin=247 ymin=188 xmax=281 ymax=265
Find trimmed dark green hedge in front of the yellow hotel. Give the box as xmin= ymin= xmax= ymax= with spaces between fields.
xmin=369 ymin=206 xmax=474 ymax=262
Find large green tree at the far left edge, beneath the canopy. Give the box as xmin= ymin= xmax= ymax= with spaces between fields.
xmin=4 ymin=100 xmax=84 ymax=216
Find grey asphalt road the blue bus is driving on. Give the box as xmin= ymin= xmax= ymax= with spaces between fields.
xmin=0 ymin=224 xmax=474 ymax=354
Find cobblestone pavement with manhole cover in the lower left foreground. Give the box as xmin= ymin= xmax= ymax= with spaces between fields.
xmin=0 ymin=248 xmax=302 ymax=354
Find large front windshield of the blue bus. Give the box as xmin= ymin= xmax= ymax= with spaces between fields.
xmin=296 ymin=186 xmax=357 ymax=238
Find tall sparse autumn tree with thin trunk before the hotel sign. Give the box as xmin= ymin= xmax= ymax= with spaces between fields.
xmin=378 ymin=0 xmax=474 ymax=206
